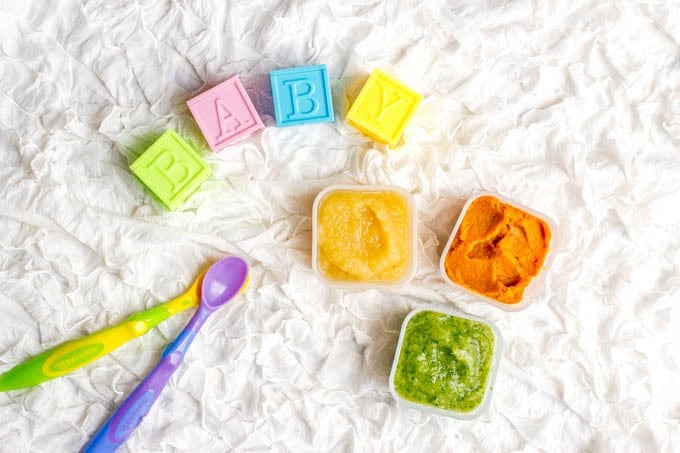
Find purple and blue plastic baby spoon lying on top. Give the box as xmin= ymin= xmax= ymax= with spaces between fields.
xmin=83 ymin=256 xmax=248 ymax=452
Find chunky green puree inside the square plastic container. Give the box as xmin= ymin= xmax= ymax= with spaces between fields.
xmin=394 ymin=311 xmax=494 ymax=412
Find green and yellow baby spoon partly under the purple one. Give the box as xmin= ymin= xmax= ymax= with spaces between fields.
xmin=0 ymin=272 xmax=205 ymax=392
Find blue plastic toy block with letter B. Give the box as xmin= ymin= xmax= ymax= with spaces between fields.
xmin=269 ymin=64 xmax=335 ymax=127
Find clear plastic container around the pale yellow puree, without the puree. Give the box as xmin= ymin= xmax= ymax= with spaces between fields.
xmin=312 ymin=185 xmax=418 ymax=289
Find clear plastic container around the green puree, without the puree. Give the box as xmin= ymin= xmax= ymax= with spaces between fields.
xmin=389 ymin=305 xmax=503 ymax=420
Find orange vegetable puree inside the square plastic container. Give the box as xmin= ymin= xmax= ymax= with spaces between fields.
xmin=444 ymin=196 xmax=551 ymax=304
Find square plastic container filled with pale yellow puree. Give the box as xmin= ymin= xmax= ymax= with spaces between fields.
xmin=312 ymin=186 xmax=416 ymax=287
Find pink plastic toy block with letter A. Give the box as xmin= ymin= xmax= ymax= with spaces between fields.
xmin=187 ymin=76 xmax=264 ymax=151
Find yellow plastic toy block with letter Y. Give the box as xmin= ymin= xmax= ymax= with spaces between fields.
xmin=347 ymin=69 xmax=423 ymax=147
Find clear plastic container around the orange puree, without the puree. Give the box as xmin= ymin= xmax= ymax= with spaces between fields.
xmin=439 ymin=192 xmax=559 ymax=311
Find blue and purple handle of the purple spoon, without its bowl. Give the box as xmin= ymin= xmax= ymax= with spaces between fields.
xmin=83 ymin=305 xmax=210 ymax=453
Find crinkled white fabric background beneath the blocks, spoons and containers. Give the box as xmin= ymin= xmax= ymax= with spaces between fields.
xmin=0 ymin=0 xmax=680 ymax=452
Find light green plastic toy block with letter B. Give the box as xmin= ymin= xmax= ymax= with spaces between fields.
xmin=130 ymin=129 xmax=210 ymax=209
